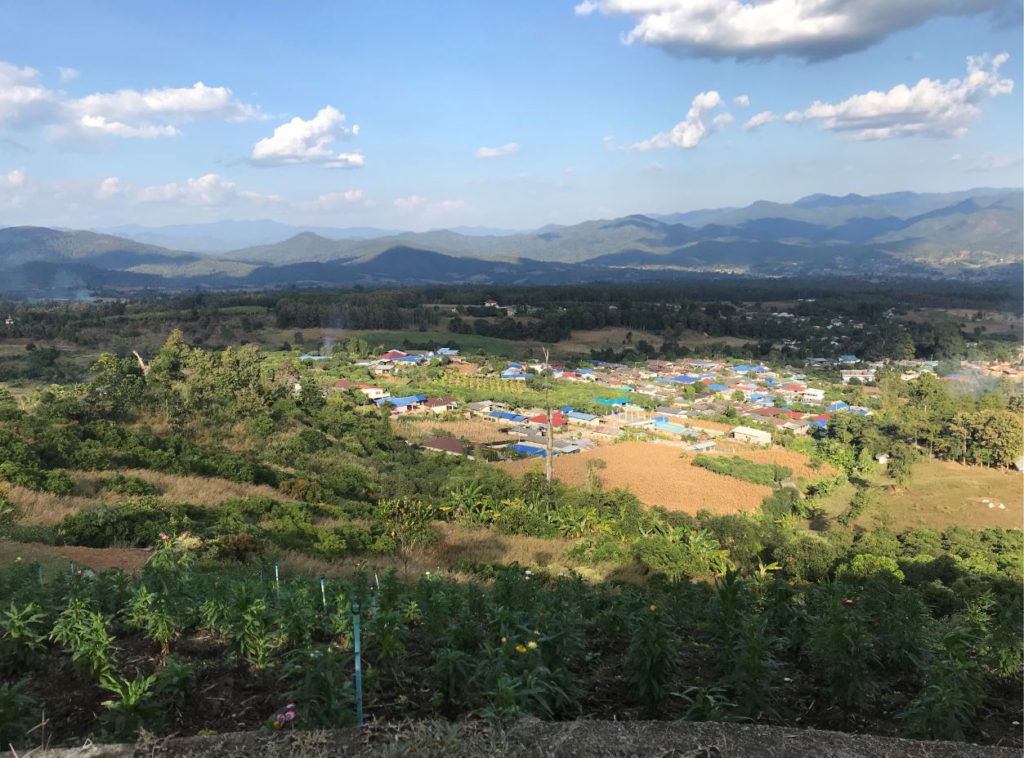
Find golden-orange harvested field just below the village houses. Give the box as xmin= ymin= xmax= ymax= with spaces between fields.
xmin=498 ymin=441 xmax=771 ymax=513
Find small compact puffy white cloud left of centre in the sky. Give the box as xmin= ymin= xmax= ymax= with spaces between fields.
xmin=252 ymin=106 xmax=365 ymax=168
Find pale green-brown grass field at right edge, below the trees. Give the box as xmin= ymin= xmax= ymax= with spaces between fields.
xmin=823 ymin=461 xmax=1024 ymax=531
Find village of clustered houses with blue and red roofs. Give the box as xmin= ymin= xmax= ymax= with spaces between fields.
xmin=297 ymin=338 xmax=1020 ymax=464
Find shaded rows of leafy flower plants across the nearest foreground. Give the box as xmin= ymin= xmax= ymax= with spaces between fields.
xmin=0 ymin=533 xmax=1021 ymax=747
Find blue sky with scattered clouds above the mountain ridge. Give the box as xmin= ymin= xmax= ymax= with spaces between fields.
xmin=0 ymin=0 xmax=1024 ymax=229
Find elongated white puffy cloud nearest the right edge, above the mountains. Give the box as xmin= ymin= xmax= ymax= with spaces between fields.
xmin=785 ymin=53 xmax=1014 ymax=139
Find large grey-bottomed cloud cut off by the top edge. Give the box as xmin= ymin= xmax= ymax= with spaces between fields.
xmin=575 ymin=0 xmax=1013 ymax=60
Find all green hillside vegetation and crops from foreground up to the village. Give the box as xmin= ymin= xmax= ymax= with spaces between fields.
xmin=0 ymin=299 xmax=1024 ymax=747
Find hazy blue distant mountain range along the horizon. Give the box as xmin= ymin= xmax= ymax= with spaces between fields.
xmin=0 ymin=188 xmax=1024 ymax=297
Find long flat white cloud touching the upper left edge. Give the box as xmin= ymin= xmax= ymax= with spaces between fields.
xmin=0 ymin=61 xmax=260 ymax=139
